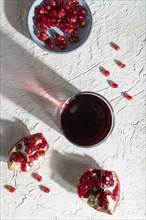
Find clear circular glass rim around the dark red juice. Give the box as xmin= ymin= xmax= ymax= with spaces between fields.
xmin=59 ymin=91 xmax=115 ymax=148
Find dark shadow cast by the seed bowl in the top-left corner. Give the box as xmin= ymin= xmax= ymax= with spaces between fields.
xmin=4 ymin=0 xmax=34 ymax=38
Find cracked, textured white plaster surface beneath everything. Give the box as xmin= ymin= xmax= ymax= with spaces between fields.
xmin=0 ymin=0 xmax=145 ymax=220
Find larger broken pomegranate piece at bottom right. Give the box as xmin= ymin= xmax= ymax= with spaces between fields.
xmin=78 ymin=169 xmax=120 ymax=214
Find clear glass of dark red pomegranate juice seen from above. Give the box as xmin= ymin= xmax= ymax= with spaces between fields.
xmin=60 ymin=92 xmax=115 ymax=147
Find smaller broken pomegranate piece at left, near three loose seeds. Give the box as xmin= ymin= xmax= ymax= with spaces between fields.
xmin=8 ymin=133 xmax=49 ymax=172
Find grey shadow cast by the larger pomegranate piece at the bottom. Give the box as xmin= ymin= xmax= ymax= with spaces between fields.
xmin=49 ymin=150 xmax=100 ymax=193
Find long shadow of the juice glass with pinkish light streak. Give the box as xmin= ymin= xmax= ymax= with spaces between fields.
xmin=1 ymin=34 xmax=79 ymax=133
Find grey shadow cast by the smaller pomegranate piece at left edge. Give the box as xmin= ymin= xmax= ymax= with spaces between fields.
xmin=0 ymin=118 xmax=30 ymax=161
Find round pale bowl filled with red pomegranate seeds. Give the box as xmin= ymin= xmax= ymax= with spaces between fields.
xmin=27 ymin=0 xmax=92 ymax=53
